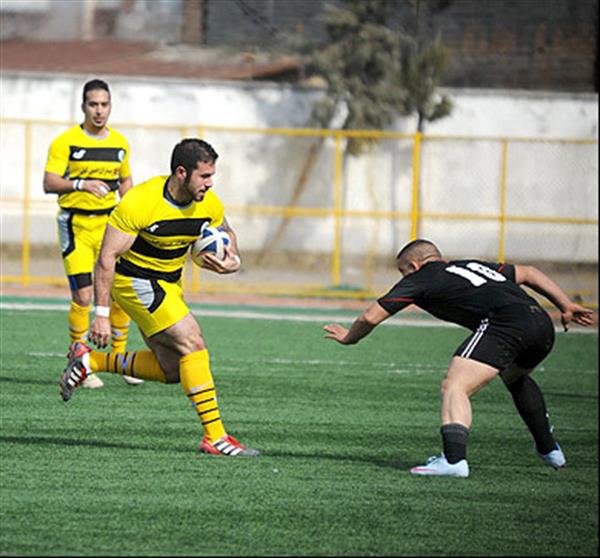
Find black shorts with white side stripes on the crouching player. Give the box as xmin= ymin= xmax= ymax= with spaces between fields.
xmin=454 ymin=304 xmax=554 ymax=370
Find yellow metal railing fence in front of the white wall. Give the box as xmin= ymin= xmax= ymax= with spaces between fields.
xmin=0 ymin=119 xmax=598 ymax=304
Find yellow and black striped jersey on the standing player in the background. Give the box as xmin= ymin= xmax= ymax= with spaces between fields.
xmin=45 ymin=124 xmax=131 ymax=211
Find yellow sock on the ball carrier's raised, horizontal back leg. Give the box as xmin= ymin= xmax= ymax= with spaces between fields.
xmin=89 ymin=351 xmax=167 ymax=384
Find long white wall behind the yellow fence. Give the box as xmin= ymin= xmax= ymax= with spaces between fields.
xmin=0 ymin=72 xmax=598 ymax=262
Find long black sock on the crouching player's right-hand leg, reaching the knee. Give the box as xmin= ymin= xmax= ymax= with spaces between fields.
xmin=506 ymin=376 xmax=556 ymax=454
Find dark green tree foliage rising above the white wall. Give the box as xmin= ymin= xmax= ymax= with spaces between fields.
xmin=308 ymin=0 xmax=452 ymax=148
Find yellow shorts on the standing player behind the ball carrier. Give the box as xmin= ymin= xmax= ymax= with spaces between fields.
xmin=56 ymin=209 xmax=108 ymax=289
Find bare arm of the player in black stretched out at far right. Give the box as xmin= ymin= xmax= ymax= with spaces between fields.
xmin=515 ymin=265 xmax=595 ymax=331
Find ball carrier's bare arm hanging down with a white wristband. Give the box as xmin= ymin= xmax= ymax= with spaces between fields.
xmin=89 ymin=224 xmax=136 ymax=349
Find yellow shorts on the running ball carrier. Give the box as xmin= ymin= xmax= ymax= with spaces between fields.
xmin=112 ymin=273 xmax=190 ymax=337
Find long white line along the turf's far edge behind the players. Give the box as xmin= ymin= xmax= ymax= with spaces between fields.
xmin=0 ymin=302 xmax=598 ymax=334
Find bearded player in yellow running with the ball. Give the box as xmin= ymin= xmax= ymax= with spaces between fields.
xmin=61 ymin=139 xmax=259 ymax=457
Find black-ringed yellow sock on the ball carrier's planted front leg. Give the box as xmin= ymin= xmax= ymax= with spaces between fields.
xmin=179 ymin=349 xmax=225 ymax=442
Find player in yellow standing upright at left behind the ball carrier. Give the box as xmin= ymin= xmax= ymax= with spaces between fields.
xmin=44 ymin=79 xmax=140 ymax=388
